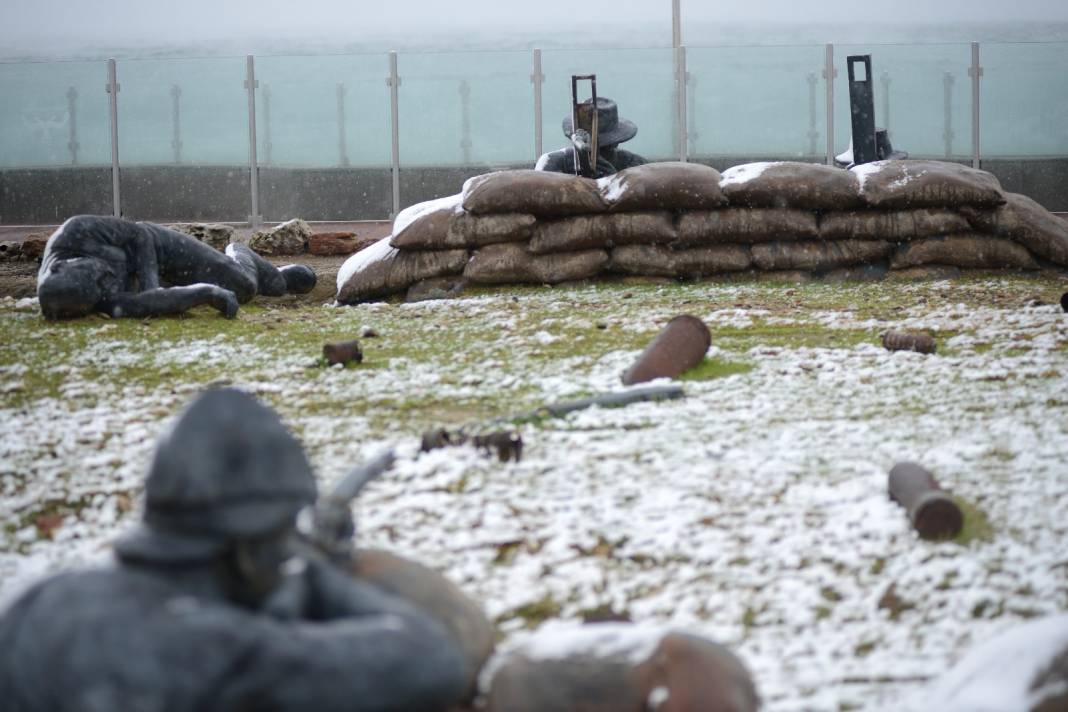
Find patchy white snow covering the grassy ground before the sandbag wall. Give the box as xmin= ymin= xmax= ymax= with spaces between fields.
xmin=0 ymin=283 xmax=1068 ymax=712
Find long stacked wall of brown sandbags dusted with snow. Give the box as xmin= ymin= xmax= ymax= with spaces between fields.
xmin=337 ymin=160 xmax=1068 ymax=303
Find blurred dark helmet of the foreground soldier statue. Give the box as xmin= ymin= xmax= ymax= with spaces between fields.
xmin=115 ymin=389 xmax=316 ymax=564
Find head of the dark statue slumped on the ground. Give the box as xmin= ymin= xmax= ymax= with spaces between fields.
xmin=37 ymin=257 xmax=117 ymax=319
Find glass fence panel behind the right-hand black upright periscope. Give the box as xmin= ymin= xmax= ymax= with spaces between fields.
xmin=834 ymin=44 xmax=972 ymax=161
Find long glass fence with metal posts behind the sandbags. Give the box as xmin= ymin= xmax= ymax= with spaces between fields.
xmin=0 ymin=43 xmax=1068 ymax=223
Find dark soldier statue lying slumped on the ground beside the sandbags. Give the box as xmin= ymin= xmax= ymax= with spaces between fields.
xmin=37 ymin=216 xmax=315 ymax=319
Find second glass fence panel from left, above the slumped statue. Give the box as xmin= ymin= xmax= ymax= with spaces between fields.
xmin=116 ymin=57 xmax=251 ymax=222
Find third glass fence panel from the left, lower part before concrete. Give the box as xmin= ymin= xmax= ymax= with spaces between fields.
xmin=256 ymin=54 xmax=393 ymax=221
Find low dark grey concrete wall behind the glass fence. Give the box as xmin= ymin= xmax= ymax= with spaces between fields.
xmin=0 ymin=157 xmax=1068 ymax=225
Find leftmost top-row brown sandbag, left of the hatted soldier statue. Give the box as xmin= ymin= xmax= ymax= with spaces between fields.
xmin=462 ymin=170 xmax=607 ymax=217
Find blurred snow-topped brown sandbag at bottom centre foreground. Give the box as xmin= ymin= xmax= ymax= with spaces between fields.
xmin=482 ymin=623 xmax=760 ymax=712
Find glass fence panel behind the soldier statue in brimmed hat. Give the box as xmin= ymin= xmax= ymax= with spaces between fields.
xmin=541 ymin=49 xmax=678 ymax=160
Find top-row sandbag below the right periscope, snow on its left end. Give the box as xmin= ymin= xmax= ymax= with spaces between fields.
xmin=849 ymin=160 xmax=1005 ymax=209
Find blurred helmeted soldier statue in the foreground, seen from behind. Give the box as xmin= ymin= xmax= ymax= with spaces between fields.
xmin=0 ymin=390 xmax=470 ymax=712
